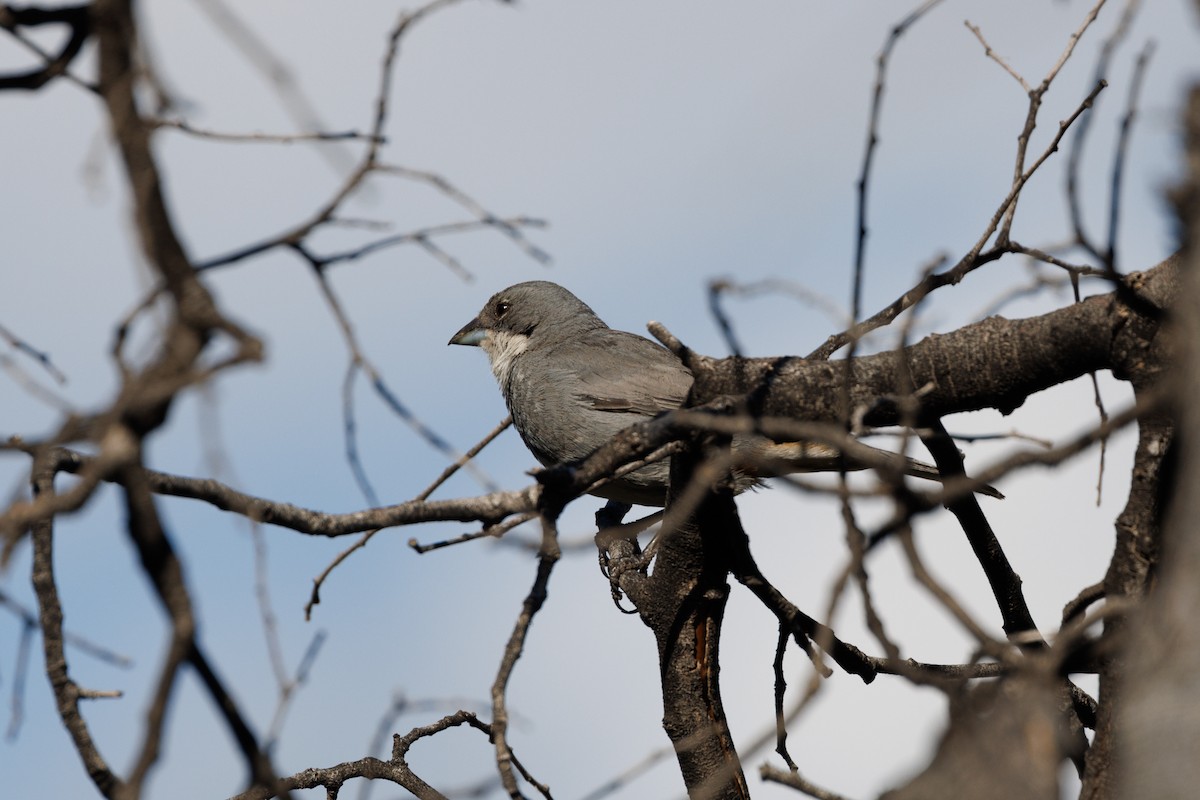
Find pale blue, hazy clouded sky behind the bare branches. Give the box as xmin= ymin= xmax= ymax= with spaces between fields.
xmin=0 ymin=0 xmax=1198 ymax=800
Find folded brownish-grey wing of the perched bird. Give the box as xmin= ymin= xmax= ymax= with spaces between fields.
xmin=570 ymin=329 xmax=692 ymax=416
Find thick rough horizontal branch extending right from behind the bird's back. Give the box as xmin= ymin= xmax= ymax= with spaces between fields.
xmin=679 ymin=257 xmax=1178 ymax=426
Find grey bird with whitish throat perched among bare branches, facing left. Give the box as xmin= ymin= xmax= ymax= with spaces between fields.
xmin=450 ymin=281 xmax=1000 ymax=506
